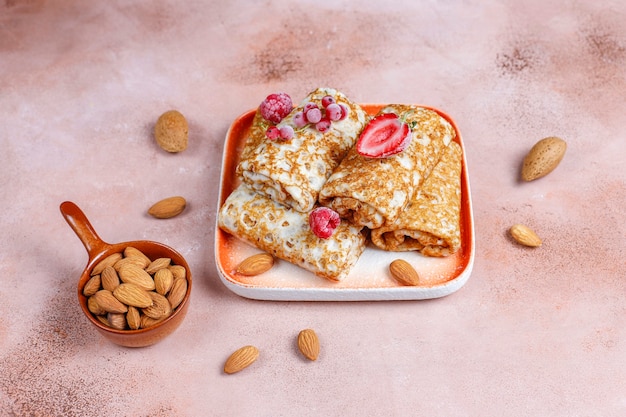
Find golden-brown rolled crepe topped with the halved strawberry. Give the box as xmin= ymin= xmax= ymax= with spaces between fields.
xmin=319 ymin=105 xmax=456 ymax=229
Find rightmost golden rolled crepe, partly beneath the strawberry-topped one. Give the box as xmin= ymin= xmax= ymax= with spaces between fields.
xmin=371 ymin=142 xmax=462 ymax=256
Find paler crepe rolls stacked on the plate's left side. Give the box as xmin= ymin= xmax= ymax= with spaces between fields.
xmin=218 ymin=88 xmax=369 ymax=281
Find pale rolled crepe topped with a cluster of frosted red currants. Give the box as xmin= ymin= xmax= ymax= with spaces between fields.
xmin=237 ymin=88 xmax=369 ymax=212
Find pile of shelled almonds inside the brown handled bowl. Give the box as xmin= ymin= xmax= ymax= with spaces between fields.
xmin=83 ymin=246 xmax=188 ymax=330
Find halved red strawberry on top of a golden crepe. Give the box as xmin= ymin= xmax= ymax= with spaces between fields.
xmin=356 ymin=113 xmax=411 ymax=158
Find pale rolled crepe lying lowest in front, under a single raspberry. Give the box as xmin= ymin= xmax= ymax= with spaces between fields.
xmin=218 ymin=183 xmax=366 ymax=281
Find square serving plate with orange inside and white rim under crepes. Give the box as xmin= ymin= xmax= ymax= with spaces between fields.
xmin=215 ymin=104 xmax=475 ymax=301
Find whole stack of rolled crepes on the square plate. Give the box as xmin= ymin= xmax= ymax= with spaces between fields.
xmin=218 ymin=95 xmax=462 ymax=281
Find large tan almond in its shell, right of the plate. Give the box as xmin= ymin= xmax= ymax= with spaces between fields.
xmin=522 ymin=136 xmax=567 ymax=181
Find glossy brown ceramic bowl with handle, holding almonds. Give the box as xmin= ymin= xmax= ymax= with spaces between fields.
xmin=60 ymin=201 xmax=191 ymax=347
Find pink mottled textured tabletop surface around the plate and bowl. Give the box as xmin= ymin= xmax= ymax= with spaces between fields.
xmin=0 ymin=0 xmax=626 ymax=416
